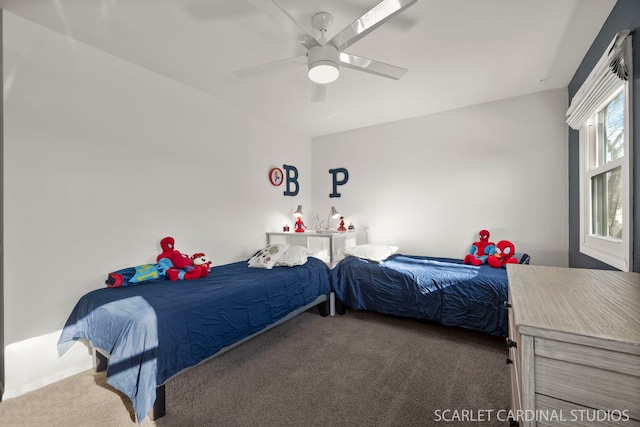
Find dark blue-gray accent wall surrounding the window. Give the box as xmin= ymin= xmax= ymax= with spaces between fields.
xmin=568 ymin=0 xmax=640 ymax=271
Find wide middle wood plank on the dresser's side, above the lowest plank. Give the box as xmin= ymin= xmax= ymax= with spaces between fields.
xmin=534 ymin=358 xmax=640 ymax=420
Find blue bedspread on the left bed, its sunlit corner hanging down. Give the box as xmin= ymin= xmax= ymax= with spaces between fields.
xmin=58 ymin=257 xmax=330 ymax=423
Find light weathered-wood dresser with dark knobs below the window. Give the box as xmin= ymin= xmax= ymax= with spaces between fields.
xmin=507 ymin=264 xmax=640 ymax=427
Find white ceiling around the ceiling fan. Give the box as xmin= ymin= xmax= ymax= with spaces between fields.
xmin=0 ymin=0 xmax=615 ymax=136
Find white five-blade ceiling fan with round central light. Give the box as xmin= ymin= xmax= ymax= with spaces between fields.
xmin=234 ymin=0 xmax=417 ymax=101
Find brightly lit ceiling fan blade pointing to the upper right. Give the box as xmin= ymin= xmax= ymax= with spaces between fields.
xmin=328 ymin=0 xmax=418 ymax=51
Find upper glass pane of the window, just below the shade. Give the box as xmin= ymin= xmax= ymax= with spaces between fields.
xmin=595 ymin=92 xmax=624 ymax=167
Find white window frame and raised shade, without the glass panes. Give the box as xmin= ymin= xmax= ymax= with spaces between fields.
xmin=567 ymin=33 xmax=633 ymax=271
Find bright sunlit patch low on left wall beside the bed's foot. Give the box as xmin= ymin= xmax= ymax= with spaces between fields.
xmin=2 ymin=331 xmax=93 ymax=400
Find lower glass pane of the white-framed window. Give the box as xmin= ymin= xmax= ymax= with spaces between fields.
xmin=591 ymin=167 xmax=622 ymax=239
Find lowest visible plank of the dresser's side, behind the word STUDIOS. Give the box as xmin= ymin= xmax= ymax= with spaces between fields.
xmin=536 ymin=394 xmax=640 ymax=427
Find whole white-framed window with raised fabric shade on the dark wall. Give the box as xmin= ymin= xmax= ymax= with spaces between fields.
xmin=567 ymin=32 xmax=633 ymax=271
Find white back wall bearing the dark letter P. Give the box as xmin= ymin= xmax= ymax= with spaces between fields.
xmin=312 ymin=89 xmax=568 ymax=266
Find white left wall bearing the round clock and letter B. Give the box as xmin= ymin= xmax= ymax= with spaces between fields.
xmin=2 ymin=11 xmax=311 ymax=397
